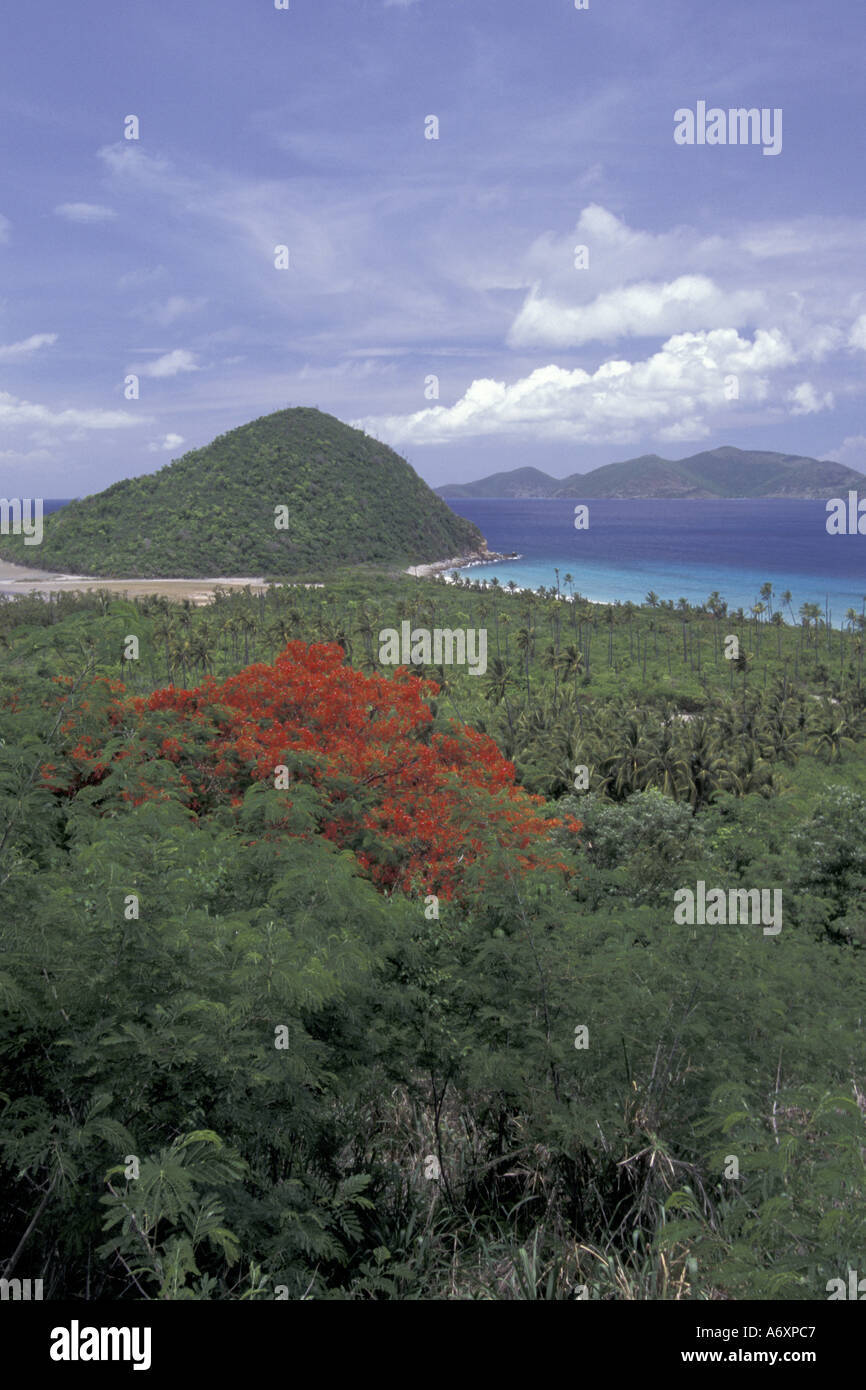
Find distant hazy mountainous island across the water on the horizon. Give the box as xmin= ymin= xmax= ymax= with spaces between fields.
xmin=435 ymin=446 xmax=866 ymax=499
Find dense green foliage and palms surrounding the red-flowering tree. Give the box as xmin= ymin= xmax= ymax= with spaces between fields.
xmin=0 ymin=578 xmax=866 ymax=1300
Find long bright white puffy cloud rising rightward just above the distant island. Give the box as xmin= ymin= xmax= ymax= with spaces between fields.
xmin=357 ymin=328 xmax=794 ymax=443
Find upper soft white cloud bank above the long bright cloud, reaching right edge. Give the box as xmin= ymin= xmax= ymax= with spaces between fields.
xmin=507 ymin=203 xmax=866 ymax=361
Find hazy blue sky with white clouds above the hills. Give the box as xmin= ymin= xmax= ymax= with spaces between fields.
xmin=0 ymin=0 xmax=866 ymax=496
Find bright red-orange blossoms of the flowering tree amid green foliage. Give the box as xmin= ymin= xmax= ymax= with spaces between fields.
xmin=45 ymin=642 xmax=580 ymax=898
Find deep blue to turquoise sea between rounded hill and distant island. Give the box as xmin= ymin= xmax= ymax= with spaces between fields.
xmin=448 ymin=498 xmax=866 ymax=627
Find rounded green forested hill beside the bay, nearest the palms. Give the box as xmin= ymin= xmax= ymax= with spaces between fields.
xmin=0 ymin=407 xmax=484 ymax=578
